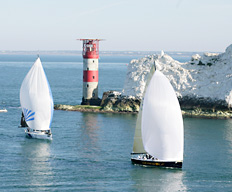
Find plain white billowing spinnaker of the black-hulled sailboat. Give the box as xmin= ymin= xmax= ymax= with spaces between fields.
xmin=142 ymin=71 xmax=184 ymax=161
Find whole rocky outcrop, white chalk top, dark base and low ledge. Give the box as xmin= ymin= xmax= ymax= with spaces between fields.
xmin=54 ymin=45 xmax=232 ymax=118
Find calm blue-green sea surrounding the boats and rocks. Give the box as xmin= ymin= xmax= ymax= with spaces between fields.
xmin=0 ymin=52 xmax=232 ymax=192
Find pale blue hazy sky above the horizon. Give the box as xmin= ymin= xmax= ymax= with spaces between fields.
xmin=0 ymin=0 xmax=232 ymax=52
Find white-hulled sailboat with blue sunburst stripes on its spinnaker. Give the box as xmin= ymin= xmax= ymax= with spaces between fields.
xmin=20 ymin=57 xmax=54 ymax=140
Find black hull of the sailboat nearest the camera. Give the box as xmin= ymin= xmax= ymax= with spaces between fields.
xmin=131 ymin=158 xmax=182 ymax=168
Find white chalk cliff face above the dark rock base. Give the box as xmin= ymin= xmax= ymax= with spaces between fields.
xmin=122 ymin=45 xmax=232 ymax=107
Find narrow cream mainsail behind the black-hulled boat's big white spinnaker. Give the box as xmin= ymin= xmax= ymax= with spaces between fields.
xmin=132 ymin=65 xmax=155 ymax=153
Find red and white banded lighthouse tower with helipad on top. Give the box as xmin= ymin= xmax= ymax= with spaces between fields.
xmin=79 ymin=39 xmax=101 ymax=105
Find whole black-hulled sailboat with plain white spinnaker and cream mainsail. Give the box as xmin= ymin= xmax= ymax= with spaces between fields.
xmin=131 ymin=67 xmax=184 ymax=168
